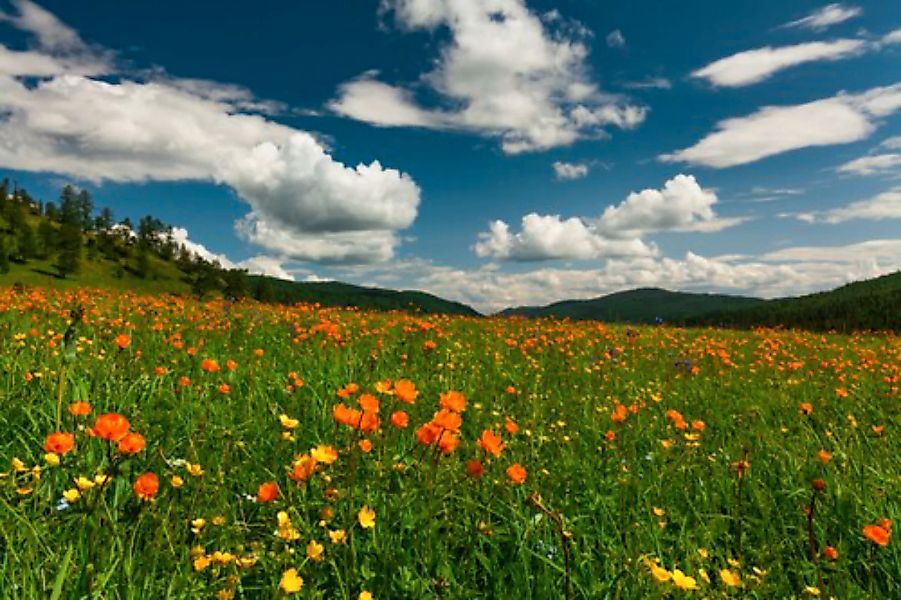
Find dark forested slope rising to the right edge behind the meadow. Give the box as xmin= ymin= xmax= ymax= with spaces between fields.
xmin=687 ymin=271 xmax=901 ymax=331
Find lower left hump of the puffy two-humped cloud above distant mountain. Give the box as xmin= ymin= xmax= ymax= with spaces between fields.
xmin=474 ymin=213 xmax=657 ymax=262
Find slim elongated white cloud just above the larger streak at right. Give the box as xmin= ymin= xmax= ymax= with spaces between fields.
xmin=691 ymin=39 xmax=867 ymax=87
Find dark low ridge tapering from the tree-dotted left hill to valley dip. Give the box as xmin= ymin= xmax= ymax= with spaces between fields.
xmin=248 ymin=275 xmax=479 ymax=316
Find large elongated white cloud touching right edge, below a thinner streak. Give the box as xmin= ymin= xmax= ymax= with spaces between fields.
xmin=659 ymin=84 xmax=901 ymax=168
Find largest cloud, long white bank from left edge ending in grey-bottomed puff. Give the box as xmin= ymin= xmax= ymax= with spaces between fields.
xmin=0 ymin=1 xmax=420 ymax=262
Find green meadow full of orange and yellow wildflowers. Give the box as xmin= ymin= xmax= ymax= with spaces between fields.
xmin=0 ymin=288 xmax=901 ymax=600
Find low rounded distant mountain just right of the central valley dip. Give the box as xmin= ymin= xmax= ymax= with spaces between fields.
xmin=500 ymin=288 xmax=763 ymax=323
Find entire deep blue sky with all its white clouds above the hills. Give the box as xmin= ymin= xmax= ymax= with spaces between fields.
xmin=0 ymin=0 xmax=901 ymax=313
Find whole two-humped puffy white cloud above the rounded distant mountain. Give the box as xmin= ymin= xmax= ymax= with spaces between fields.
xmin=474 ymin=174 xmax=743 ymax=262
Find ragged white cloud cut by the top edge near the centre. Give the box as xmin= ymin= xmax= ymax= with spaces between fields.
xmin=329 ymin=0 xmax=647 ymax=154
